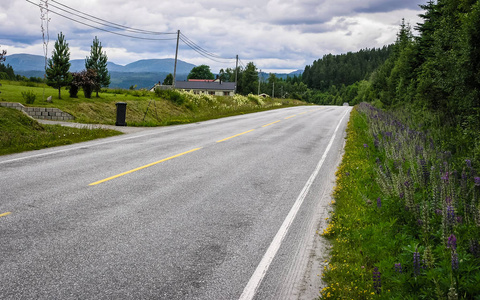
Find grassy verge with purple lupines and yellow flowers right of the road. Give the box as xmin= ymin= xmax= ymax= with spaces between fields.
xmin=321 ymin=104 xmax=480 ymax=299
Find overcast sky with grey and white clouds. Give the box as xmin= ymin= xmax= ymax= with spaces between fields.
xmin=0 ymin=0 xmax=427 ymax=72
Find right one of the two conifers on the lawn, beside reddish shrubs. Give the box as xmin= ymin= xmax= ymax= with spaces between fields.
xmin=85 ymin=37 xmax=110 ymax=97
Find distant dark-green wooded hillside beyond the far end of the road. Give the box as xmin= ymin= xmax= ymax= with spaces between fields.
xmin=303 ymin=45 xmax=393 ymax=92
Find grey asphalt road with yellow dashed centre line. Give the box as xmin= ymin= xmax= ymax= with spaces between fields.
xmin=0 ymin=106 xmax=351 ymax=299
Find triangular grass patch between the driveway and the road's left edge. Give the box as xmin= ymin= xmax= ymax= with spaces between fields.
xmin=0 ymin=107 xmax=121 ymax=155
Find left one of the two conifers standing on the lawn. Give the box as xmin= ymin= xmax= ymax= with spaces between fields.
xmin=46 ymin=32 xmax=72 ymax=99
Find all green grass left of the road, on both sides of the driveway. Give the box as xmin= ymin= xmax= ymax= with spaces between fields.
xmin=0 ymin=81 xmax=306 ymax=155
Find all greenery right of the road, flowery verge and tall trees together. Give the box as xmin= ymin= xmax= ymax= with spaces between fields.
xmin=321 ymin=0 xmax=480 ymax=300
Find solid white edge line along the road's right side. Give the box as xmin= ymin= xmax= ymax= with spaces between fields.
xmin=239 ymin=110 xmax=350 ymax=300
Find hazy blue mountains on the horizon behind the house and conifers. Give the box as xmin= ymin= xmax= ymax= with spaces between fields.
xmin=4 ymin=54 xmax=195 ymax=89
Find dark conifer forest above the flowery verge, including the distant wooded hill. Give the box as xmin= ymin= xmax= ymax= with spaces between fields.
xmin=302 ymin=0 xmax=480 ymax=167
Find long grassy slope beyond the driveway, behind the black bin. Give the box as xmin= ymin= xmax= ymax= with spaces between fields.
xmin=0 ymin=81 xmax=306 ymax=126
